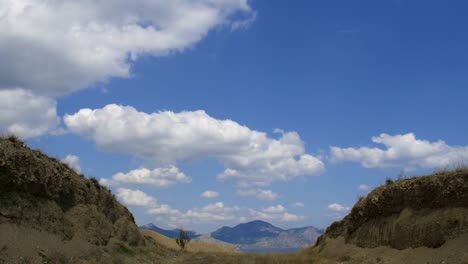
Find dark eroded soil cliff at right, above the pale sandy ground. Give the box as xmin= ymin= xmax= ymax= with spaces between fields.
xmin=317 ymin=169 xmax=468 ymax=249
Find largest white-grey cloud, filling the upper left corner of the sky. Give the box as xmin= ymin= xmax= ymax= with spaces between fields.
xmin=0 ymin=0 xmax=255 ymax=96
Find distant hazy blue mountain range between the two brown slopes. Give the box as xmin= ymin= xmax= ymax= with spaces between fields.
xmin=140 ymin=220 xmax=323 ymax=252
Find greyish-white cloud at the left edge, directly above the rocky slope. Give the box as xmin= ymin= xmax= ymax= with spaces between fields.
xmin=0 ymin=88 xmax=60 ymax=139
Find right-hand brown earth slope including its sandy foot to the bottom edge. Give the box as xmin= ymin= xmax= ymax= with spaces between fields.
xmin=311 ymin=169 xmax=468 ymax=263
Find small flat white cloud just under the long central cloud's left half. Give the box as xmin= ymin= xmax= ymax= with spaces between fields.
xmin=112 ymin=166 xmax=192 ymax=187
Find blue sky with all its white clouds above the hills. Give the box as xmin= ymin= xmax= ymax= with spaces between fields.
xmin=0 ymin=0 xmax=468 ymax=232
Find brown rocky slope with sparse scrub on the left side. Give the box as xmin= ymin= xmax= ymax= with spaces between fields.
xmin=0 ymin=137 xmax=145 ymax=263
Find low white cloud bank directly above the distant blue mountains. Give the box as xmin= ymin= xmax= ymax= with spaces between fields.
xmin=146 ymin=202 xmax=304 ymax=225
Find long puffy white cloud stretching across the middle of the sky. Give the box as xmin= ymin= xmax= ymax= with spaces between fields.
xmin=64 ymin=104 xmax=324 ymax=186
